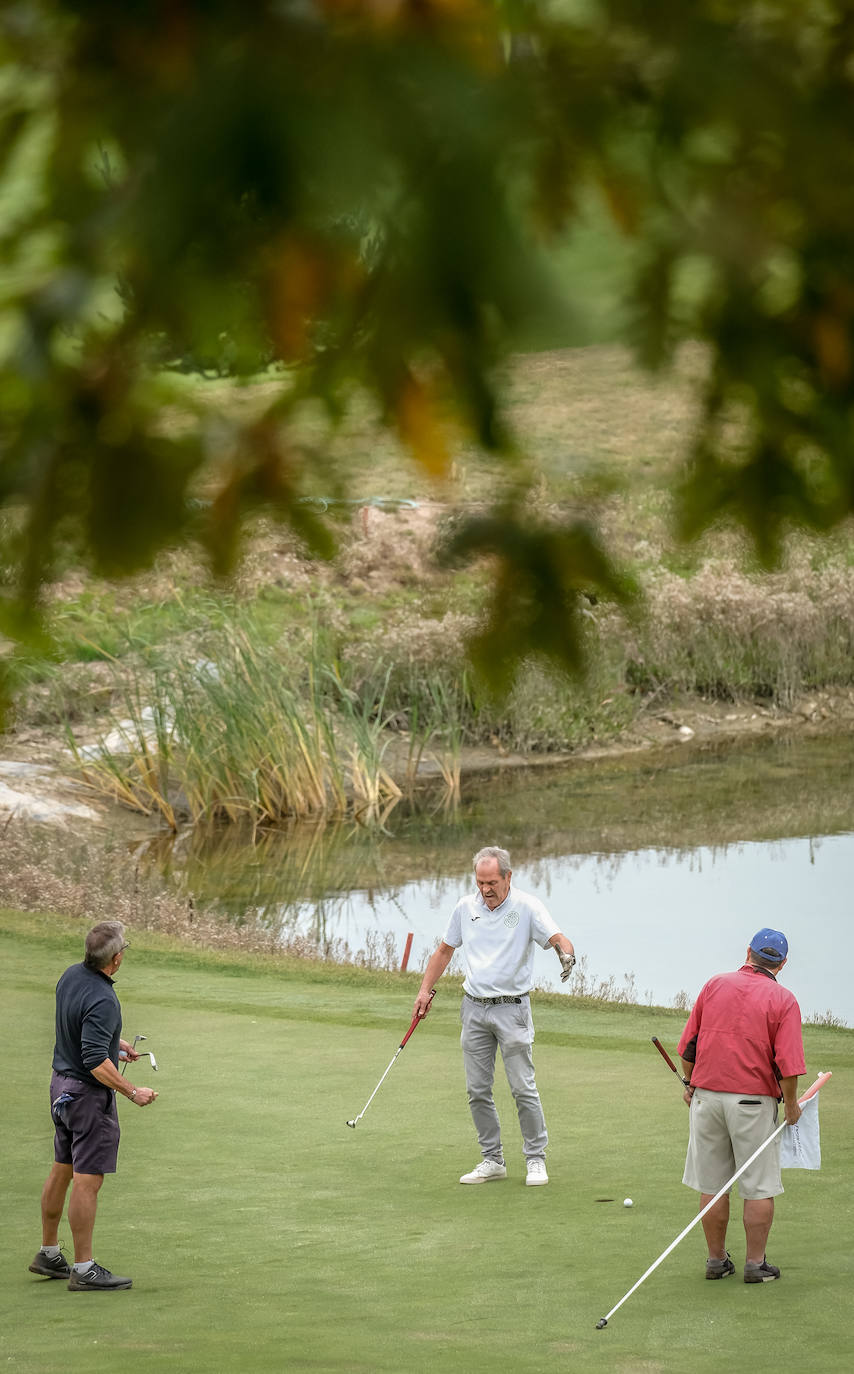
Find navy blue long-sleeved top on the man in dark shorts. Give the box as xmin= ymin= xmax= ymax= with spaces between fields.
xmin=54 ymin=963 xmax=122 ymax=1087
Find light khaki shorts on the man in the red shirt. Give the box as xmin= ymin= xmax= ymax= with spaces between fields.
xmin=682 ymin=1088 xmax=783 ymax=1201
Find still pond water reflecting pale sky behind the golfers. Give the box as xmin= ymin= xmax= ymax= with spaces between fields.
xmin=152 ymin=735 xmax=854 ymax=1025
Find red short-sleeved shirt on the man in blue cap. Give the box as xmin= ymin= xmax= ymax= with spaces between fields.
xmin=678 ymin=963 xmax=806 ymax=1098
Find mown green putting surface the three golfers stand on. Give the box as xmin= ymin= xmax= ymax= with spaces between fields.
xmin=0 ymin=912 xmax=854 ymax=1374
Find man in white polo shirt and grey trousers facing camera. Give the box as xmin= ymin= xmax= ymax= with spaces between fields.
xmin=413 ymin=845 xmax=575 ymax=1186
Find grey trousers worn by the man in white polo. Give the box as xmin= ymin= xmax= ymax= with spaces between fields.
xmin=460 ymin=993 xmax=549 ymax=1161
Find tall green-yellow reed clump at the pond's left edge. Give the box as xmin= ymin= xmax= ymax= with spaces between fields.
xmin=69 ymin=628 xmax=420 ymax=830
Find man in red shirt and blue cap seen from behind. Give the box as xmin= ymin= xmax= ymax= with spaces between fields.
xmin=678 ymin=927 xmax=806 ymax=1283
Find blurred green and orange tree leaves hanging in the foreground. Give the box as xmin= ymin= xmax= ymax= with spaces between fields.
xmin=0 ymin=0 xmax=854 ymax=719
